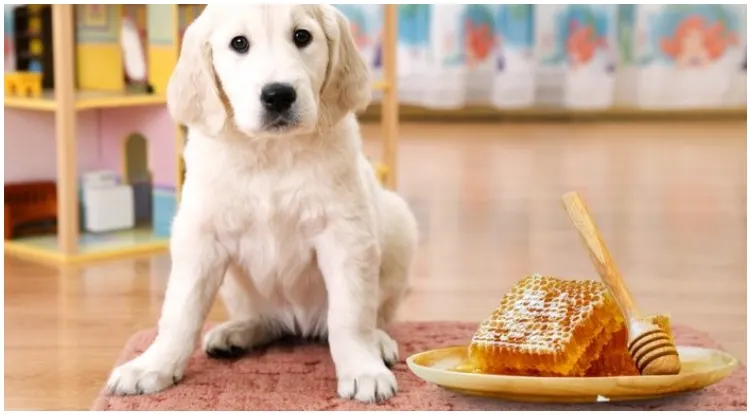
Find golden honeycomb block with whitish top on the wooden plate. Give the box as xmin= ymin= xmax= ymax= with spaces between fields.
xmin=469 ymin=275 xmax=624 ymax=376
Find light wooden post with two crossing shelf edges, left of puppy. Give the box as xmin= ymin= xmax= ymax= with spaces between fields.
xmin=4 ymin=4 xmax=168 ymax=264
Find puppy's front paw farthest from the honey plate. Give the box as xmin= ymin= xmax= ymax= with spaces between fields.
xmin=107 ymin=356 xmax=183 ymax=395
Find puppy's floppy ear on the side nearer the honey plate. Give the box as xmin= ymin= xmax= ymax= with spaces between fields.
xmin=321 ymin=5 xmax=372 ymax=121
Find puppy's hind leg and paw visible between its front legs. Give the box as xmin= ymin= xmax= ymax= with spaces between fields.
xmin=203 ymin=264 xmax=280 ymax=359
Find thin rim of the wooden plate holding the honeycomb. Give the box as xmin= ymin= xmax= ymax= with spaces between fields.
xmin=406 ymin=345 xmax=739 ymax=386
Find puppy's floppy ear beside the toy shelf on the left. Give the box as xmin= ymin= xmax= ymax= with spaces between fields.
xmin=167 ymin=11 xmax=227 ymax=136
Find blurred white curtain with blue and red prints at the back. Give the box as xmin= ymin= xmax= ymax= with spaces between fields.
xmin=352 ymin=4 xmax=746 ymax=110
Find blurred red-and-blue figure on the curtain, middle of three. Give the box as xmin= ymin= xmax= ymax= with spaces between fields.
xmin=562 ymin=5 xmax=612 ymax=70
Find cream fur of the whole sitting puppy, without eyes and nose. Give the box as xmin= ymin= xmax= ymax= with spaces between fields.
xmin=108 ymin=5 xmax=417 ymax=402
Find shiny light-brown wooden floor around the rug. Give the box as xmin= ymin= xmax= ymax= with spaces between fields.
xmin=5 ymin=122 xmax=746 ymax=409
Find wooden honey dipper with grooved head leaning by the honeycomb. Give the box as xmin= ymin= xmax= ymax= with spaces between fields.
xmin=563 ymin=192 xmax=681 ymax=375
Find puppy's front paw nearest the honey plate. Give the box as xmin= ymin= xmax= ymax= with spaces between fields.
xmin=337 ymin=366 xmax=396 ymax=403
